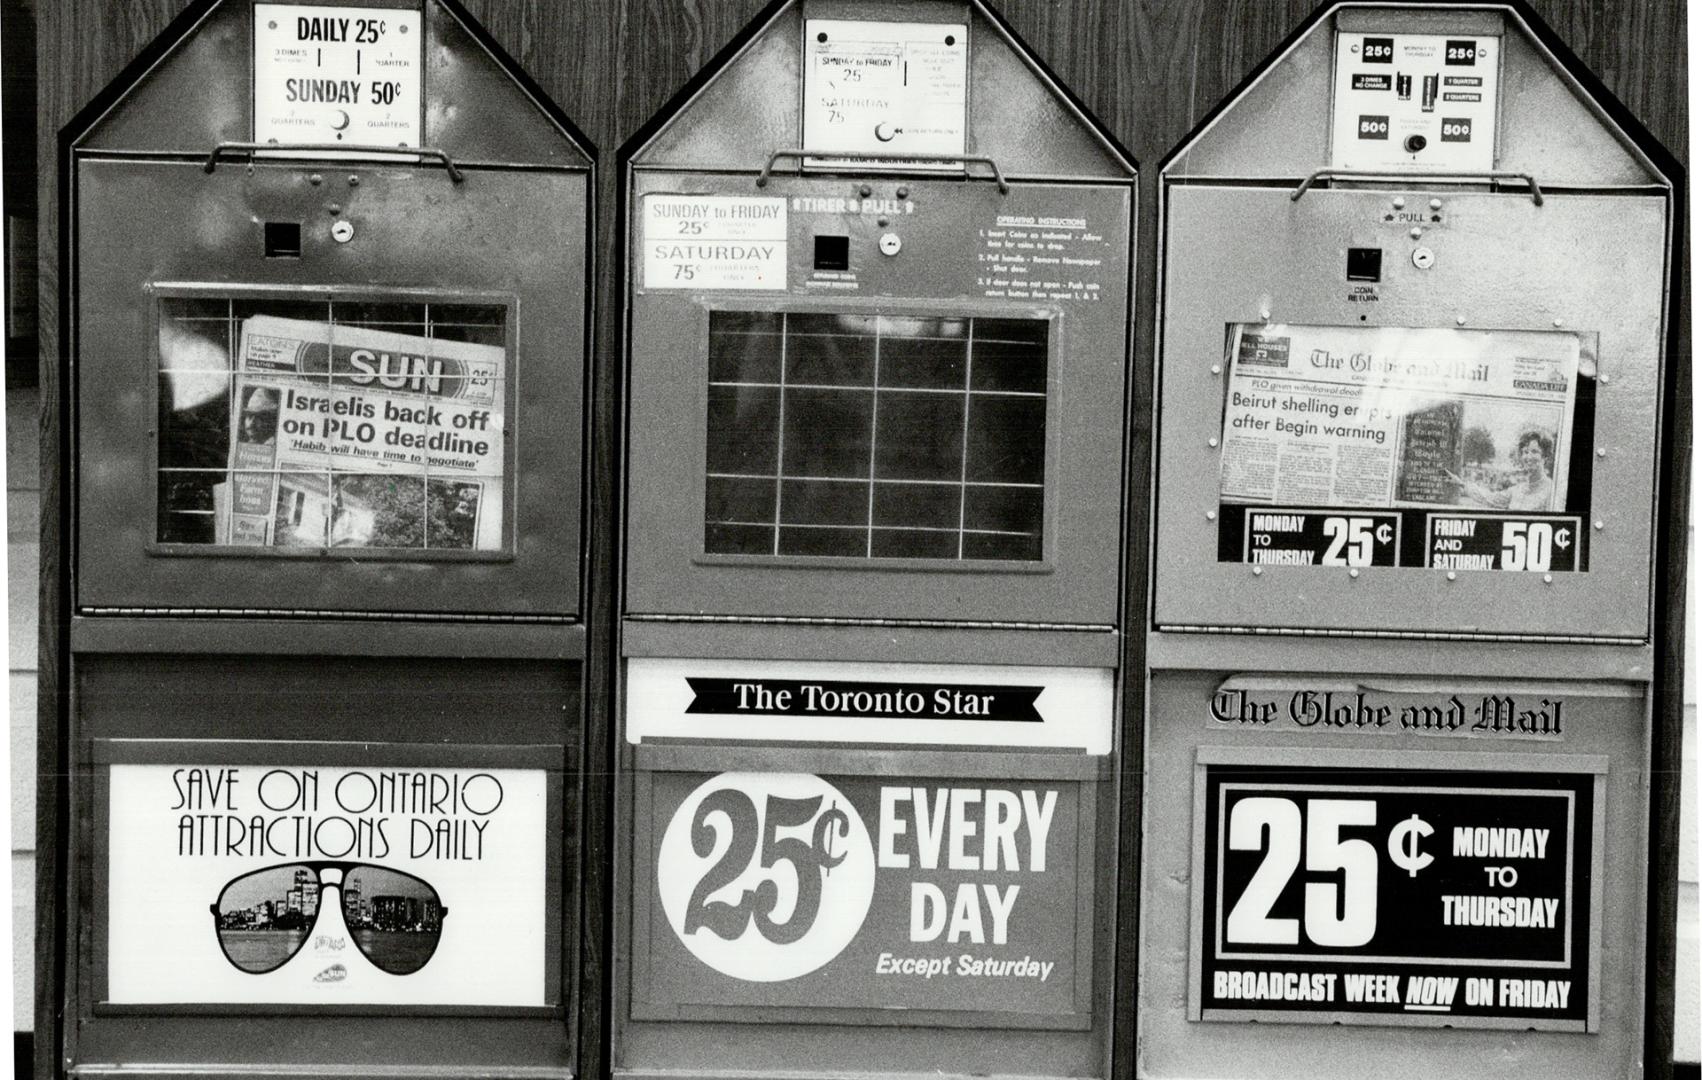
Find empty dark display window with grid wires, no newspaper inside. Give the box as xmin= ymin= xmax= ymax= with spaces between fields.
xmin=703 ymin=311 xmax=1048 ymax=561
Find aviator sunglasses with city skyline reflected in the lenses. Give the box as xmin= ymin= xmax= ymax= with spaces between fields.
xmin=209 ymin=861 xmax=449 ymax=975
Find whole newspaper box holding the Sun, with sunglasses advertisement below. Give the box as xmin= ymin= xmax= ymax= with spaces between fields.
xmin=53 ymin=0 xmax=592 ymax=1077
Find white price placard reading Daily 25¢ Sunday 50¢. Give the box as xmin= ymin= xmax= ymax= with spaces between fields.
xmin=254 ymin=3 xmax=424 ymax=146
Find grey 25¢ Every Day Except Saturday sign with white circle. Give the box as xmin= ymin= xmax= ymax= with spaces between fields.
xmin=648 ymin=772 xmax=1091 ymax=1017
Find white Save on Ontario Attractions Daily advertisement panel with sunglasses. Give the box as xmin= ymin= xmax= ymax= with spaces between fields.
xmin=104 ymin=764 xmax=550 ymax=1007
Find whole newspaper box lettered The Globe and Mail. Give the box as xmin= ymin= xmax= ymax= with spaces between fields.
xmin=1139 ymin=3 xmax=1676 ymax=1077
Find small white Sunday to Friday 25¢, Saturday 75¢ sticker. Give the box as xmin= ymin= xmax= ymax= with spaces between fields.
xmin=643 ymin=194 xmax=786 ymax=289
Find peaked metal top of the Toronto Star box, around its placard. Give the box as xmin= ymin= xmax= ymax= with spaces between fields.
xmin=621 ymin=0 xmax=1137 ymax=180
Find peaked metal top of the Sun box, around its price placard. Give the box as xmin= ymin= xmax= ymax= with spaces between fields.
xmin=60 ymin=0 xmax=596 ymax=168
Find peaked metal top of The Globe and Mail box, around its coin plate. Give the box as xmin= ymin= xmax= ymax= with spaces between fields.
xmin=1159 ymin=0 xmax=1682 ymax=187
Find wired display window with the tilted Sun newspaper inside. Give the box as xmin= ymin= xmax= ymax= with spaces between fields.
xmin=157 ymin=296 xmax=511 ymax=553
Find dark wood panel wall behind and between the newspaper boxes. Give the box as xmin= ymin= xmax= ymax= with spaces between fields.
xmin=29 ymin=0 xmax=1690 ymax=1077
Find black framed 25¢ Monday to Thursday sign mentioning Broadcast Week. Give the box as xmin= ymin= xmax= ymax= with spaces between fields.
xmin=1188 ymin=747 xmax=1607 ymax=1031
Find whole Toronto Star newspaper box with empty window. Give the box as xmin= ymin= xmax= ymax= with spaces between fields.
xmin=611 ymin=0 xmax=1135 ymax=1077
